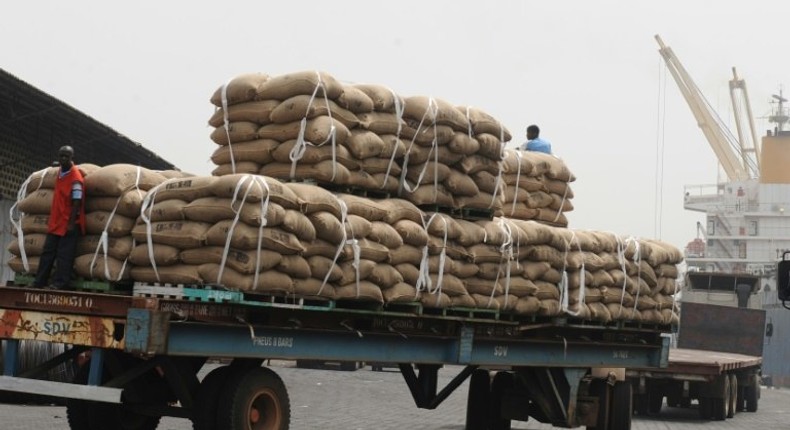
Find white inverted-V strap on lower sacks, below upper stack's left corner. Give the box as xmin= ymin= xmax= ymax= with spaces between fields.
xmin=217 ymin=175 xmax=269 ymax=289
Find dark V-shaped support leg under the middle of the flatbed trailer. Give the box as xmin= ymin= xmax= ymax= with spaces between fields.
xmin=398 ymin=363 xmax=477 ymax=409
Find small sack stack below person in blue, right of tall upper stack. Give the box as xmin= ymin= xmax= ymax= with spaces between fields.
xmin=496 ymin=149 xmax=576 ymax=227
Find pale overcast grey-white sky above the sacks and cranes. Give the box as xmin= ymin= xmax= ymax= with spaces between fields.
xmin=0 ymin=0 xmax=790 ymax=252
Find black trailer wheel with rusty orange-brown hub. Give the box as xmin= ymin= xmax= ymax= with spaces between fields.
xmin=217 ymin=367 xmax=291 ymax=430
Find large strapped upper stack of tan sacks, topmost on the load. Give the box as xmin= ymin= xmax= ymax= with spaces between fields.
xmin=204 ymin=72 xmax=510 ymax=214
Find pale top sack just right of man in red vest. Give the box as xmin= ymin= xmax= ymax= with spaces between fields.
xmin=85 ymin=164 xmax=166 ymax=197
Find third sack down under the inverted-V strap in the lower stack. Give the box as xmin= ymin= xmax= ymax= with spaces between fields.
xmin=205 ymin=220 xmax=305 ymax=254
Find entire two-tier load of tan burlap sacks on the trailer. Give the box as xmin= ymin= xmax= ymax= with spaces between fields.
xmin=6 ymin=72 xmax=682 ymax=324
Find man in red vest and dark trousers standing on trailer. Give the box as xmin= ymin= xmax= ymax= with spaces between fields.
xmin=33 ymin=146 xmax=85 ymax=290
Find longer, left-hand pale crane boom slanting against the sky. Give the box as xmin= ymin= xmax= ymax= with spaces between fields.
xmin=656 ymin=35 xmax=749 ymax=181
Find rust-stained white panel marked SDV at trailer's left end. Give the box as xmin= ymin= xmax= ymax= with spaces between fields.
xmin=0 ymin=310 xmax=125 ymax=349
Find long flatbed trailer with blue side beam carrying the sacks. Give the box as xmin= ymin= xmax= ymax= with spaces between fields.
xmin=0 ymin=284 xmax=669 ymax=430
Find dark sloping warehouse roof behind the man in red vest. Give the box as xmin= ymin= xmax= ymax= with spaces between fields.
xmin=0 ymin=69 xmax=175 ymax=196
